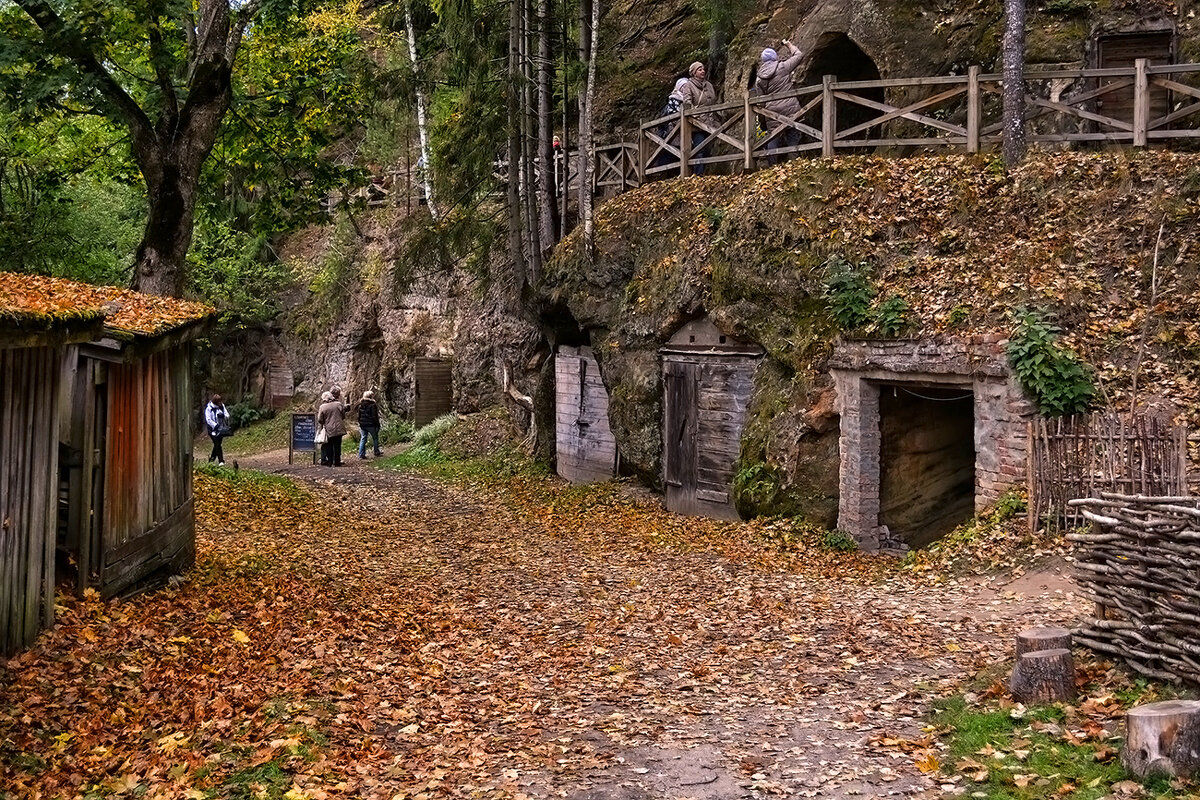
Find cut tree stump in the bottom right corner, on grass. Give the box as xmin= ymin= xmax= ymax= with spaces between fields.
xmin=1121 ymin=700 xmax=1200 ymax=778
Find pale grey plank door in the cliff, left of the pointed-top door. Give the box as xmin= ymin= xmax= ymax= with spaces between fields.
xmin=554 ymin=345 xmax=617 ymax=483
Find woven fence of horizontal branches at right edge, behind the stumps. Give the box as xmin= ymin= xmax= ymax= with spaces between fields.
xmin=1067 ymin=494 xmax=1200 ymax=684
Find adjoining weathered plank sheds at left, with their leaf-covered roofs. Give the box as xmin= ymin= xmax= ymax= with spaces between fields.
xmin=0 ymin=272 xmax=212 ymax=651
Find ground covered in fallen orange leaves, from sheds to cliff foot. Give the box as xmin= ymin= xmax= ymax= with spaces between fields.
xmin=0 ymin=469 xmax=1081 ymax=800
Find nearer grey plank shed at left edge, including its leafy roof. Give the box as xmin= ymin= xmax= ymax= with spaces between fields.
xmin=0 ymin=278 xmax=104 ymax=655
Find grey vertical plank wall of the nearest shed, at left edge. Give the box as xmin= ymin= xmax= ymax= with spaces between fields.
xmin=0 ymin=348 xmax=62 ymax=654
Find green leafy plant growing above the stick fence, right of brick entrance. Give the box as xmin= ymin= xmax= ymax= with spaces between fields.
xmin=1008 ymin=308 xmax=1096 ymax=416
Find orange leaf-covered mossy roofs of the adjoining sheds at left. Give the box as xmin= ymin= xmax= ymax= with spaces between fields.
xmin=0 ymin=272 xmax=215 ymax=339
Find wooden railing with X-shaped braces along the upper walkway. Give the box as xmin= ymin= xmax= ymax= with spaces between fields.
xmin=330 ymin=59 xmax=1200 ymax=214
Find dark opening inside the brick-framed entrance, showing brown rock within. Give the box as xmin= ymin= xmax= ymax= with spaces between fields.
xmin=878 ymin=383 xmax=976 ymax=549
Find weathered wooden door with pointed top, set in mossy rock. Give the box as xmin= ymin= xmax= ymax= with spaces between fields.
xmin=659 ymin=319 xmax=763 ymax=519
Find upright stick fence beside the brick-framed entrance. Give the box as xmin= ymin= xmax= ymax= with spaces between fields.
xmin=1027 ymin=411 xmax=1188 ymax=530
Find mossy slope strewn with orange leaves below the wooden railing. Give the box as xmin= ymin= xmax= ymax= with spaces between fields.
xmin=542 ymin=152 xmax=1200 ymax=513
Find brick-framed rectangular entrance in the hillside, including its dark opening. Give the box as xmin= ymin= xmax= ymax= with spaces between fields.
xmin=830 ymin=337 xmax=1036 ymax=551
